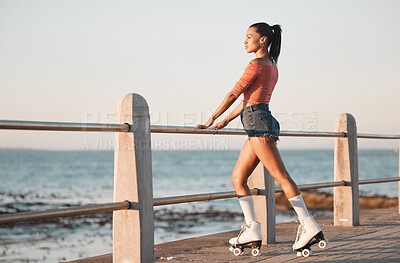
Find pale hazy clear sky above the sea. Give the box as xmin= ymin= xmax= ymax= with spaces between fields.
xmin=0 ymin=0 xmax=400 ymax=150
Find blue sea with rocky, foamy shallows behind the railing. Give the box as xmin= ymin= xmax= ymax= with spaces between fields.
xmin=0 ymin=150 xmax=399 ymax=262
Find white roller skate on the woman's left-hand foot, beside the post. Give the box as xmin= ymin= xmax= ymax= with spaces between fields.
xmin=229 ymin=221 xmax=262 ymax=256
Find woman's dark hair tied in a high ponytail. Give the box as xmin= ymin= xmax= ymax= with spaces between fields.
xmin=250 ymin=22 xmax=282 ymax=64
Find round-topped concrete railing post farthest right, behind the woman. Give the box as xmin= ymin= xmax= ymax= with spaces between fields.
xmin=333 ymin=113 xmax=360 ymax=226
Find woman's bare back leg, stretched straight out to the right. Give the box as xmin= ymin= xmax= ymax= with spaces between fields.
xmin=249 ymin=137 xmax=300 ymax=199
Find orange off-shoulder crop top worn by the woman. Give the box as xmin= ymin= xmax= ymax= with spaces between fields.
xmin=230 ymin=63 xmax=278 ymax=104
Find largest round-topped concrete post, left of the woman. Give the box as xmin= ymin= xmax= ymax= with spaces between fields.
xmin=113 ymin=94 xmax=154 ymax=263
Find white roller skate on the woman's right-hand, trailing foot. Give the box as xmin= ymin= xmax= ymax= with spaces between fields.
xmin=293 ymin=216 xmax=328 ymax=257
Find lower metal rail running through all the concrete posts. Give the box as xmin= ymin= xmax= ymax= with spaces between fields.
xmin=0 ymin=177 xmax=400 ymax=225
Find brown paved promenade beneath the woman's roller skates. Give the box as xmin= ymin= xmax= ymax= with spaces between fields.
xmin=67 ymin=207 xmax=400 ymax=263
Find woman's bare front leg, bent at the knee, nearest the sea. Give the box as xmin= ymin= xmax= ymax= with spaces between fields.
xmin=231 ymin=140 xmax=260 ymax=197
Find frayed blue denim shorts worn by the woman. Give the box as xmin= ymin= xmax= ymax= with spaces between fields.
xmin=240 ymin=104 xmax=280 ymax=141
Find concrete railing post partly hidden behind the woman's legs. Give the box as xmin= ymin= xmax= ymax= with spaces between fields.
xmin=247 ymin=162 xmax=276 ymax=244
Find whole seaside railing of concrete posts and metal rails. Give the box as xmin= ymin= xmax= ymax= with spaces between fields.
xmin=0 ymin=94 xmax=400 ymax=262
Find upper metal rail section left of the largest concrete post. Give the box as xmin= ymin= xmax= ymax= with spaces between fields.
xmin=0 ymin=120 xmax=129 ymax=132
